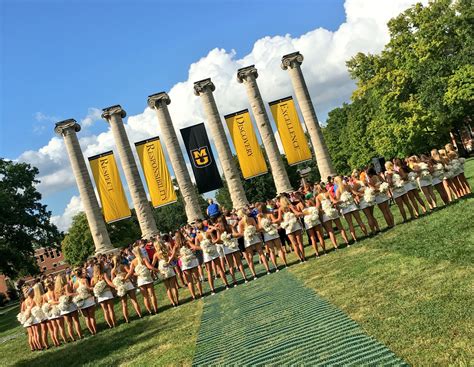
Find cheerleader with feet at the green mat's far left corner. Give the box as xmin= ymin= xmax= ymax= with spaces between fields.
xmin=174 ymin=231 xmax=202 ymax=300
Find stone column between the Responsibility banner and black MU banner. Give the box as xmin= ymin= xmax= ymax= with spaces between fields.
xmin=148 ymin=92 xmax=203 ymax=223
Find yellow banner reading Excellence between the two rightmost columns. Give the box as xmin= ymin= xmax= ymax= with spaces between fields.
xmin=270 ymin=97 xmax=311 ymax=165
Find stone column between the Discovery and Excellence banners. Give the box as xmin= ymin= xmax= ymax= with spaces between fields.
xmin=237 ymin=65 xmax=293 ymax=194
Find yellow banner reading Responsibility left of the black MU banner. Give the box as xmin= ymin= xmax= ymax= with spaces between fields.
xmin=135 ymin=137 xmax=176 ymax=208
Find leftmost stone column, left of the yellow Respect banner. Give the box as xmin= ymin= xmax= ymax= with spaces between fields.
xmin=54 ymin=119 xmax=113 ymax=254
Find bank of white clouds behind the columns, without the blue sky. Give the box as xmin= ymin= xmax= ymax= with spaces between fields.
xmin=14 ymin=0 xmax=427 ymax=230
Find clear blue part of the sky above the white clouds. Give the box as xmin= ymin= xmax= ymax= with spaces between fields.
xmin=0 ymin=0 xmax=344 ymax=158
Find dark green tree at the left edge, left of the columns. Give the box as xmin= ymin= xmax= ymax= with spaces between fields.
xmin=0 ymin=159 xmax=62 ymax=278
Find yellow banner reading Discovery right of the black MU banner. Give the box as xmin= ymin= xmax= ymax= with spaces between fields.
xmin=225 ymin=110 xmax=268 ymax=179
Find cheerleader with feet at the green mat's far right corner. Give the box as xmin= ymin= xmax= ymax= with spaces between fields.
xmin=257 ymin=203 xmax=288 ymax=271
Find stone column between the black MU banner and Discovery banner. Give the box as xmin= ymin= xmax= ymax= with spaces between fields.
xmin=194 ymin=78 xmax=248 ymax=209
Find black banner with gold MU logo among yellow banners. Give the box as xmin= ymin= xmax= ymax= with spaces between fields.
xmin=181 ymin=123 xmax=222 ymax=194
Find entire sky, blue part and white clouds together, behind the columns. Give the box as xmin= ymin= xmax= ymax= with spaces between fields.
xmin=0 ymin=0 xmax=418 ymax=229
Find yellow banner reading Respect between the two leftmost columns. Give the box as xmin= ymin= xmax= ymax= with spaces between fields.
xmin=89 ymin=151 xmax=131 ymax=223
